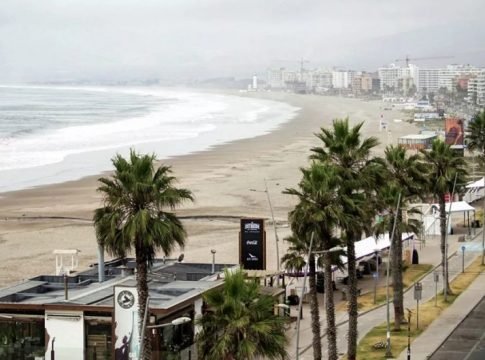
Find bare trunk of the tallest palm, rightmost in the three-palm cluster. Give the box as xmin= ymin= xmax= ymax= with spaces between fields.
xmin=347 ymin=238 xmax=359 ymax=360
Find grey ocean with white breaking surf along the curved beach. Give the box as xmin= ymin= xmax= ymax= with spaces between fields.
xmin=0 ymin=86 xmax=298 ymax=192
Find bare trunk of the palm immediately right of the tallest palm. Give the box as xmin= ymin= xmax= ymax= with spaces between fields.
xmin=391 ymin=210 xmax=404 ymax=331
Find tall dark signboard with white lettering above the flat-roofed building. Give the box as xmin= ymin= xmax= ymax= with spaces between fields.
xmin=239 ymin=219 xmax=266 ymax=270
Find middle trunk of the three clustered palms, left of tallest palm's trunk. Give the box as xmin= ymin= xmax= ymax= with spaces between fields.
xmin=323 ymin=249 xmax=338 ymax=360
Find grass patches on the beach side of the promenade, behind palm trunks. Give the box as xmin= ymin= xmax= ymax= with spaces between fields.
xmin=336 ymin=264 xmax=433 ymax=311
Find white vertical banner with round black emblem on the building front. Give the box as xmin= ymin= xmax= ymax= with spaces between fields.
xmin=114 ymin=286 xmax=140 ymax=360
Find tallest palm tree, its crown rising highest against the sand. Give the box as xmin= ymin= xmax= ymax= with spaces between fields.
xmin=310 ymin=118 xmax=382 ymax=360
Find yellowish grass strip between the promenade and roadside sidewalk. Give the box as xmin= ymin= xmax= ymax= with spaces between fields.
xmin=357 ymin=257 xmax=485 ymax=360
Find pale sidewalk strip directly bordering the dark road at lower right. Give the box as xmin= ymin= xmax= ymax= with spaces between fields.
xmin=398 ymin=275 xmax=485 ymax=360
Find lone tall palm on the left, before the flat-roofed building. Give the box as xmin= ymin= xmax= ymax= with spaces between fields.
xmin=93 ymin=150 xmax=193 ymax=359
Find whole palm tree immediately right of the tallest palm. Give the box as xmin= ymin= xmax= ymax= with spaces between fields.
xmin=378 ymin=145 xmax=427 ymax=330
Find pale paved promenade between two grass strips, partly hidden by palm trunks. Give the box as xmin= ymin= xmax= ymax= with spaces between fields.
xmin=288 ymin=232 xmax=481 ymax=360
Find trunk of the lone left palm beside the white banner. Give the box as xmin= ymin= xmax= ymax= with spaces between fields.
xmin=135 ymin=244 xmax=152 ymax=360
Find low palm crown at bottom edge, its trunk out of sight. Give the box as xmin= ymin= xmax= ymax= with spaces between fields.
xmin=197 ymin=270 xmax=288 ymax=360
